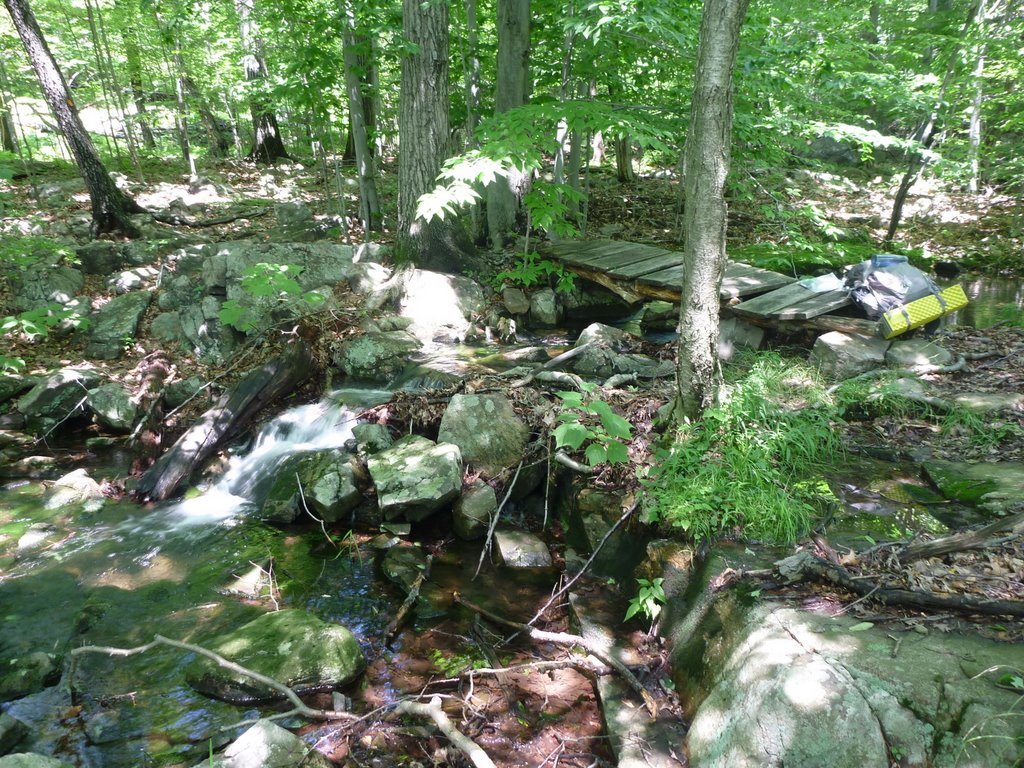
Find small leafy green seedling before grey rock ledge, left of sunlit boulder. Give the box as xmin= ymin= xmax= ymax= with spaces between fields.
xmin=219 ymin=262 xmax=327 ymax=333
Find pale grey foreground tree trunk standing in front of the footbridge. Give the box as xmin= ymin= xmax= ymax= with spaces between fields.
xmin=674 ymin=0 xmax=750 ymax=421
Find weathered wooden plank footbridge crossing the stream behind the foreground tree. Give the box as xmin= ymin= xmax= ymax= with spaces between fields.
xmin=546 ymin=240 xmax=874 ymax=333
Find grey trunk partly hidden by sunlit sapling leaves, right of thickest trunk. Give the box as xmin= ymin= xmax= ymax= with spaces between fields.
xmin=487 ymin=0 xmax=529 ymax=251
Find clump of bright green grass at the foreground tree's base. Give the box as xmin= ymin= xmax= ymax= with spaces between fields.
xmin=644 ymin=354 xmax=841 ymax=542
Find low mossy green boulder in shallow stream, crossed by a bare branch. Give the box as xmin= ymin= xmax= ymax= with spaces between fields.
xmin=185 ymin=608 xmax=367 ymax=700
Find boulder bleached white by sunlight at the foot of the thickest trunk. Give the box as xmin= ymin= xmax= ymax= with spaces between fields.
xmin=398 ymin=269 xmax=484 ymax=344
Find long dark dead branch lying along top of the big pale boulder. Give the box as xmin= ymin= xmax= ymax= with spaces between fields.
xmin=775 ymin=552 xmax=1024 ymax=617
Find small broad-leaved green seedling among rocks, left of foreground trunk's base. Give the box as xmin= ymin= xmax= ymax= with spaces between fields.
xmin=554 ymin=384 xmax=633 ymax=467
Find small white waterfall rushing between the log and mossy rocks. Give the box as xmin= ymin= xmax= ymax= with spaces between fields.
xmin=168 ymin=398 xmax=355 ymax=525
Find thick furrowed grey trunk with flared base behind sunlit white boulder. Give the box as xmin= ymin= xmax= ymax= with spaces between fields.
xmin=398 ymin=0 xmax=466 ymax=269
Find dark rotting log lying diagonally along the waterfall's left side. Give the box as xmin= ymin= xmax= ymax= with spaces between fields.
xmin=135 ymin=342 xmax=312 ymax=501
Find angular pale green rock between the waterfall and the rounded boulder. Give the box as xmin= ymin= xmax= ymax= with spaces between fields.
xmin=367 ymin=435 xmax=463 ymax=522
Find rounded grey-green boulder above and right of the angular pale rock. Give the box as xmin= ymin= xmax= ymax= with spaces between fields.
xmin=437 ymin=393 xmax=529 ymax=477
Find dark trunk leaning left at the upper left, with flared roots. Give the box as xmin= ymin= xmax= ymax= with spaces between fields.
xmin=4 ymin=0 xmax=145 ymax=238
